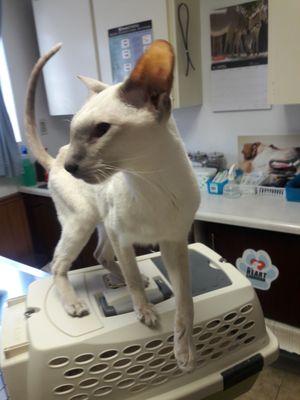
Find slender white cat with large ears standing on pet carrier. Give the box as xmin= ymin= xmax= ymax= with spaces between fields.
xmin=26 ymin=40 xmax=200 ymax=370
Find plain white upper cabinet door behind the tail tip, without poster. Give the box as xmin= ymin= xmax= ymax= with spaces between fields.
xmin=32 ymin=0 xmax=99 ymax=115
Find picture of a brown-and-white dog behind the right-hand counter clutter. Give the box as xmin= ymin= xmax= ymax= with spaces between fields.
xmin=238 ymin=134 xmax=300 ymax=187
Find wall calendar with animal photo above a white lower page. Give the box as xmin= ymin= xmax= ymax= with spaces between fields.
xmin=210 ymin=0 xmax=270 ymax=111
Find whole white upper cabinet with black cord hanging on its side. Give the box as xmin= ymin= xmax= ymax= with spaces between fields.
xmin=32 ymin=0 xmax=202 ymax=115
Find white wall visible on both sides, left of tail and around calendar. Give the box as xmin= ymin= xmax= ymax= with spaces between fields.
xmin=3 ymin=0 xmax=300 ymax=167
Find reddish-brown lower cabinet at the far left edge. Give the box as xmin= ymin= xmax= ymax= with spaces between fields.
xmin=0 ymin=194 xmax=34 ymax=265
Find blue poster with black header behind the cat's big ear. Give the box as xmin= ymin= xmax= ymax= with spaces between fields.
xmin=108 ymin=20 xmax=153 ymax=83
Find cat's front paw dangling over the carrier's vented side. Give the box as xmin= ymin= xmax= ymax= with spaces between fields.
xmin=174 ymin=328 xmax=196 ymax=372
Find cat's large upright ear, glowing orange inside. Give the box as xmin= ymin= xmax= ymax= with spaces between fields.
xmin=121 ymin=40 xmax=174 ymax=120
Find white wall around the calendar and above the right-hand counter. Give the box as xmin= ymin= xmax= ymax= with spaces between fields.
xmin=174 ymin=0 xmax=300 ymax=163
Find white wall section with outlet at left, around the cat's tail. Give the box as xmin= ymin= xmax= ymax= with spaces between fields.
xmin=2 ymin=0 xmax=70 ymax=158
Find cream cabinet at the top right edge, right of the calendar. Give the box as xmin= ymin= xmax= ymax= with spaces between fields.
xmin=268 ymin=0 xmax=300 ymax=104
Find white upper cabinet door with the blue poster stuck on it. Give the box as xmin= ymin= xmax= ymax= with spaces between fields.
xmin=93 ymin=0 xmax=168 ymax=84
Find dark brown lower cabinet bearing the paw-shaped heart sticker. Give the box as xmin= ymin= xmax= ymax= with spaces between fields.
xmin=196 ymin=222 xmax=300 ymax=327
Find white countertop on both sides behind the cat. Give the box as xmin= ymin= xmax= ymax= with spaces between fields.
xmin=19 ymin=186 xmax=300 ymax=235
